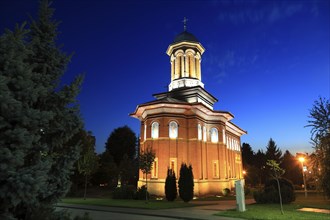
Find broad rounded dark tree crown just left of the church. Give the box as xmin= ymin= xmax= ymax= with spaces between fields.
xmin=105 ymin=126 xmax=137 ymax=167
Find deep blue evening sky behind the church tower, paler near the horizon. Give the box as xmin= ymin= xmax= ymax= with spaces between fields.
xmin=0 ymin=0 xmax=330 ymax=153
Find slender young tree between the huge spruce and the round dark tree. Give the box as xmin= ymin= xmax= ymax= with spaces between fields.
xmin=77 ymin=131 xmax=98 ymax=200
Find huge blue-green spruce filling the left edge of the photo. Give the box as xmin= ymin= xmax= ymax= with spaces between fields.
xmin=0 ymin=1 xmax=82 ymax=219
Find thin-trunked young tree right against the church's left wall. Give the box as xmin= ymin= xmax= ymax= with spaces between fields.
xmin=139 ymin=146 xmax=156 ymax=202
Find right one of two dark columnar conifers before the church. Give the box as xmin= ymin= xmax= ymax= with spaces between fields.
xmin=178 ymin=163 xmax=194 ymax=202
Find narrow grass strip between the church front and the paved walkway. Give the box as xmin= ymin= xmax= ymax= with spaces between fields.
xmin=62 ymin=198 xmax=194 ymax=209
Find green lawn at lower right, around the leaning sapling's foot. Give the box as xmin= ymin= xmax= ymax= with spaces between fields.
xmin=217 ymin=193 xmax=330 ymax=220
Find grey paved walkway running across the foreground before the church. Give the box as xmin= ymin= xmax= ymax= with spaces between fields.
xmin=57 ymin=199 xmax=254 ymax=220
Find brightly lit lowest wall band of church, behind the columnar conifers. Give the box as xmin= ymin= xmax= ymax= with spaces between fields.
xmin=138 ymin=179 xmax=238 ymax=196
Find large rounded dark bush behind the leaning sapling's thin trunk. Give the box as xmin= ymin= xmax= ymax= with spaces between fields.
xmin=253 ymin=178 xmax=295 ymax=204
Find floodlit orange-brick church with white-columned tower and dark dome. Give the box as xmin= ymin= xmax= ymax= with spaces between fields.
xmin=130 ymin=26 xmax=246 ymax=196
